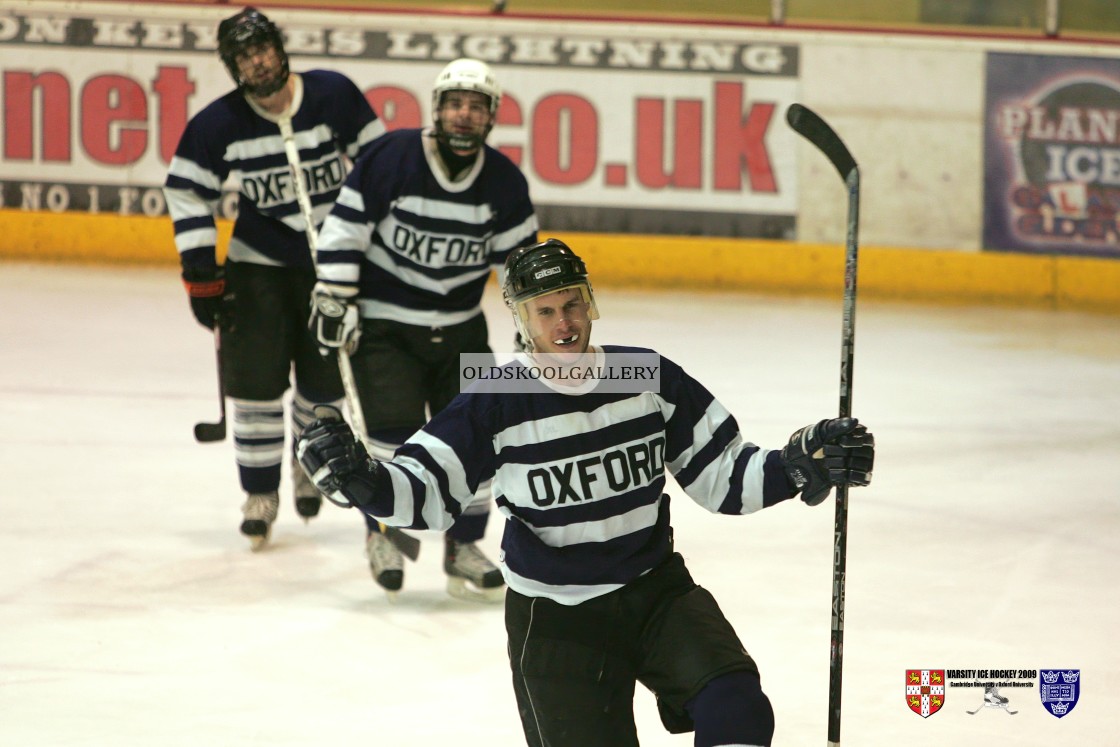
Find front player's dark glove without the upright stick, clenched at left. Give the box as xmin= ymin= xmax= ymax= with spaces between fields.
xmin=296 ymin=404 xmax=384 ymax=508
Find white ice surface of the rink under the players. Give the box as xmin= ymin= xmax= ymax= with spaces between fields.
xmin=0 ymin=259 xmax=1120 ymax=747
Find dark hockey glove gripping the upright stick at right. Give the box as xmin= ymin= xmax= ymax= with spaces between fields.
xmin=782 ymin=418 xmax=875 ymax=506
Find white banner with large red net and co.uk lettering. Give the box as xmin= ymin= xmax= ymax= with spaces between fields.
xmin=0 ymin=0 xmax=800 ymax=239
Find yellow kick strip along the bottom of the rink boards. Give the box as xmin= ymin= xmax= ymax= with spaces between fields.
xmin=0 ymin=209 xmax=1120 ymax=312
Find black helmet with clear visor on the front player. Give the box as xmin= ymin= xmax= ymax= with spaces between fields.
xmin=502 ymin=239 xmax=599 ymax=346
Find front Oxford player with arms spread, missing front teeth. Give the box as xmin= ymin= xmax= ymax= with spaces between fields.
xmin=298 ymin=239 xmax=875 ymax=747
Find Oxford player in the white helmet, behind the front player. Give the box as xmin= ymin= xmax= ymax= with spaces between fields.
xmin=312 ymin=59 xmax=536 ymax=601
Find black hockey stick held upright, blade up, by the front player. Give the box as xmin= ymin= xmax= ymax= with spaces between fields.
xmin=785 ymin=104 xmax=859 ymax=747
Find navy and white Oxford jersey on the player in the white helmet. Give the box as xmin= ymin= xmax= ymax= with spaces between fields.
xmin=318 ymin=129 xmax=536 ymax=327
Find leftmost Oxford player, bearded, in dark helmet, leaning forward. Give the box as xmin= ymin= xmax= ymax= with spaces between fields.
xmin=165 ymin=8 xmax=384 ymax=550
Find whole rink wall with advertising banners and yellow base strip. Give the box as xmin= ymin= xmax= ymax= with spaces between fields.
xmin=0 ymin=0 xmax=1120 ymax=312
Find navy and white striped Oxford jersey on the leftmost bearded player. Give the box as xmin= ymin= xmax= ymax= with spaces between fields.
xmin=164 ymin=71 xmax=385 ymax=269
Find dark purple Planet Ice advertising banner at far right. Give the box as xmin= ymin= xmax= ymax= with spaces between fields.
xmin=983 ymin=53 xmax=1120 ymax=256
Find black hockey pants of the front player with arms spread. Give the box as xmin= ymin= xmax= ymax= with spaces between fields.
xmin=505 ymin=553 xmax=773 ymax=747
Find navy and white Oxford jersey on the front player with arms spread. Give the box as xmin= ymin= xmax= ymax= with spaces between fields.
xmin=366 ymin=346 xmax=791 ymax=605
